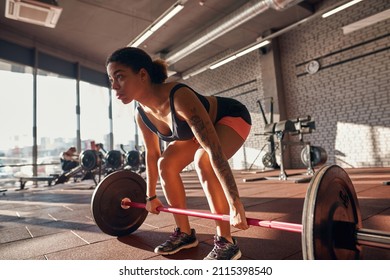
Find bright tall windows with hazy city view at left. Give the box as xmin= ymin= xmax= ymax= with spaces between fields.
xmin=0 ymin=61 xmax=136 ymax=180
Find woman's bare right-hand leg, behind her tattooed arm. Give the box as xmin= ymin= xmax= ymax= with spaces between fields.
xmin=195 ymin=124 xmax=245 ymax=242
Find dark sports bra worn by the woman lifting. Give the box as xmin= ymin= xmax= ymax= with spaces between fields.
xmin=137 ymin=84 xmax=210 ymax=142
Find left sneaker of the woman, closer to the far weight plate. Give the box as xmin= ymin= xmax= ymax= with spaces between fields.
xmin=154 ymin=228 xmax=198 ymax=255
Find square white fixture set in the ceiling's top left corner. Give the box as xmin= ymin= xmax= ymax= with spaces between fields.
xmin=5 ymin=0 xmax=62 ymax=28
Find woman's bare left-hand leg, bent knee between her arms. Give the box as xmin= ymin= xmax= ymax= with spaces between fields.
xmin=158 ymin=140 xmax=199 ymax=234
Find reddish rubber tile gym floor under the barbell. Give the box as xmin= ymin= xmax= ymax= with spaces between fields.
xmin=0 ymin=168 xmax=390 ymax=260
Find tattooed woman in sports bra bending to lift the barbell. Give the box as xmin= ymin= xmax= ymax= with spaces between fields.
xmin=106 ymin=47 xmax=251 ymax=259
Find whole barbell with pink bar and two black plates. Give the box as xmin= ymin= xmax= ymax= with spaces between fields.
xmin=91 ymin=165 xmax=390 ymax=259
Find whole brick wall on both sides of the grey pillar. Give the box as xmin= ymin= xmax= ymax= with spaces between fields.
xmin=185 ymin=0 xmax=390 ymax=169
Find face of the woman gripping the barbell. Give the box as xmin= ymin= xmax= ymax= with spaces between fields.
xmin=107 ymin=62 xmax=144 ymax=104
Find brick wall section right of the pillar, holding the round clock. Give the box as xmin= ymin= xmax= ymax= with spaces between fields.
xmin=280 ymin=0 xmax=390 ymax=167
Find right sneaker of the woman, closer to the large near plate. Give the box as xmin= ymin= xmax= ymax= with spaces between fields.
xmin=204 ymin=235 xmax=241 ymax=260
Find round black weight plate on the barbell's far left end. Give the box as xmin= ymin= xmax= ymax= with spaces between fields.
xmin=91 ymin=170 xmax=148 ymax=236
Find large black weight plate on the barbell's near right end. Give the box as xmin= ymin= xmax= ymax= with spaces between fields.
xmin=302 ymin=165 xmax=362 ymax=259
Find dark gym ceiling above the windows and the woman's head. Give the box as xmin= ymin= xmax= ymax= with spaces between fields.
xmin=0 ymin=0 xmax=323 ymax=79
